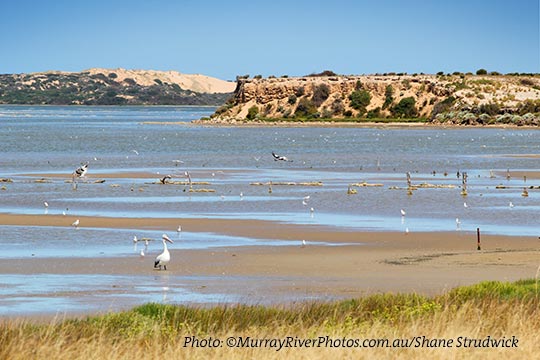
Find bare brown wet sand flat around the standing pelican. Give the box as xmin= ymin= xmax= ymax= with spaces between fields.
xmin=0 ymin=214 xmax=540 ymax=302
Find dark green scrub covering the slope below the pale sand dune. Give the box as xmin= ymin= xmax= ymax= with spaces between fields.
xmin=0 ymin=72 xmax=231 ymax=106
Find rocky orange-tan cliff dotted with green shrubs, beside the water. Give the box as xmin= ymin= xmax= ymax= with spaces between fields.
xmin=213 ymin=74 xmax=540 ymax=123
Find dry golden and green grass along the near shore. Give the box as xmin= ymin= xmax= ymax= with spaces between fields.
xmin=0 ymin=280 xmax=540 ymax=359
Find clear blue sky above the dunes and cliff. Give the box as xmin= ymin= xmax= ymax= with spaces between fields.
xmin=0 ymin=0 xmax=540 ymax=80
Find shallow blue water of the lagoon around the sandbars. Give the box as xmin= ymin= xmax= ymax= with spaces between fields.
xmin=0 ymin=106 xmax=540 ymax=314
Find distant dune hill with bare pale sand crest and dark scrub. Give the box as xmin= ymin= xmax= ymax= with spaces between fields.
xmin=0 ymin=69 xmax=235 ymax=105
